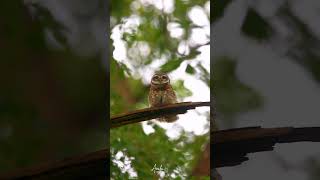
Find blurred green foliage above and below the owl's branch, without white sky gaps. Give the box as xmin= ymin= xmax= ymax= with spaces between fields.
xmin=110 ymin=0 xmax=210 ymax=179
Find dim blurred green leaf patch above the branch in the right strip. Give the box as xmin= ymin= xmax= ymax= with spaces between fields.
xmin=213 ymin=57 xmax=263 ymax=118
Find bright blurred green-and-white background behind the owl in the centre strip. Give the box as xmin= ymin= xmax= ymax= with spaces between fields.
xmin=110 ymin=0 xmax=210 ymax=179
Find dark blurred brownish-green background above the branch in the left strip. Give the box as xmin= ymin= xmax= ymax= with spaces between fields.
xmin=0 ymin=0 xmax=108 ymax=173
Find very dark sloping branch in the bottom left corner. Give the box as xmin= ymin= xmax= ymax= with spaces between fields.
xmin=0 ymin=150 xmax=109 ymax=180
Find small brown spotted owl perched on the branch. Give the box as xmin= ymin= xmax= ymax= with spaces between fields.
xmin=148 ymin=72 xmax=178 ymax=122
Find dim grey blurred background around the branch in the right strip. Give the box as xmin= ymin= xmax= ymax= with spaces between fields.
xmin=211 ymin=0 xmax=320 ymax=180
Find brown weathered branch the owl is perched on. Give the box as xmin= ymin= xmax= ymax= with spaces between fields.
xmin=111 ymin=102 xmax=210 ymax=128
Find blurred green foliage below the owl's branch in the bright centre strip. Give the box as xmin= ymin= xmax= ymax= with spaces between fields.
xmin=110 ymin=124 xmax=208 ymax=179
